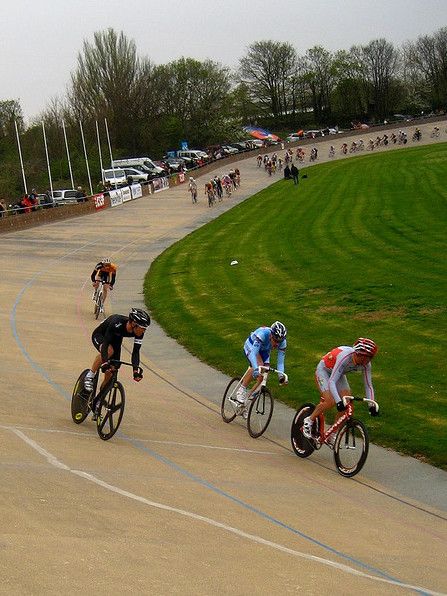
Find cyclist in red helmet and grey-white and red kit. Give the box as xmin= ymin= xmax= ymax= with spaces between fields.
xmin=303 ymin=337 xmax=378 ymax=439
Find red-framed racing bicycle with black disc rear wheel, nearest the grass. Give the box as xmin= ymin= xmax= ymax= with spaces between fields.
xmin=290 ymin=395 xmax=379 ymax=478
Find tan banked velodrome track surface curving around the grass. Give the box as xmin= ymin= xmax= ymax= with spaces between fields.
xmin=0 ymin=123 xmax=447 ymax=595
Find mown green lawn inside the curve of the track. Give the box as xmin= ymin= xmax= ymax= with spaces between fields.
xmin=145 ymin=144 xmax=447 ymax=468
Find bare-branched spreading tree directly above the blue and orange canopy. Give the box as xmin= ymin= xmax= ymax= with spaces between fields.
xmin=239 ymin=41 xmax=297 ymax=118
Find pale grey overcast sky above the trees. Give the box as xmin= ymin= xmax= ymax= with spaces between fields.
xmin=0 ymin=0 xmax=447 ymax=119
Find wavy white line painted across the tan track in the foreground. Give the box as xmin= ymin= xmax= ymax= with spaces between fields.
xmin=9 ymin=427 xmax=445 ymax=596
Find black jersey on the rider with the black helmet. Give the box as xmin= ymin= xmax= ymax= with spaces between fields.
xmin=92 ymin=315 xmax=144 ymax=369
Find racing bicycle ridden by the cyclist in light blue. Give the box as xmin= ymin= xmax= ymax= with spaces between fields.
xmin=221 ymin=366 xmax=288 ymax=439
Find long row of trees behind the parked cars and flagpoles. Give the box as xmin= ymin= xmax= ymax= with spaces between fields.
xmin=0 ymin=27 xmax=447 ymax=197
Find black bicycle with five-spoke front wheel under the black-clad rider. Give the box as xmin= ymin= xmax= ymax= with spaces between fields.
xmin=71 ymin=360 xmax=136 ymax=441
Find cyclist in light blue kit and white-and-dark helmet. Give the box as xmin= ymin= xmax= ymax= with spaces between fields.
xmin=235 ymin=321 xmax=287 ymax=405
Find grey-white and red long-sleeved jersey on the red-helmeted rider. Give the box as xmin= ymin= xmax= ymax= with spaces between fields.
xmin=315 ymin=346 xmax=374 ymax=403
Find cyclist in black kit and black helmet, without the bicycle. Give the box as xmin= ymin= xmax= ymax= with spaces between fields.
xmin=84 ymin=308 xmax=151 ymax=391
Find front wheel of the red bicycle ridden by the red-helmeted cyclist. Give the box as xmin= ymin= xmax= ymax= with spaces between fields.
xmin=334 ymin=419 xmax=369 ymax=478
